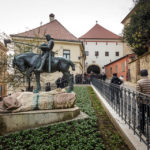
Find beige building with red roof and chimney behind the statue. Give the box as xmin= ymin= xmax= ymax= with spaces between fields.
xmin=11 ymin=14 xmax=86 ymax=88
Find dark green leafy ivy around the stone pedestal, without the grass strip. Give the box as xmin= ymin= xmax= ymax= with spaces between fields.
xmin=0 ymin=87 xmax=106 ymax=150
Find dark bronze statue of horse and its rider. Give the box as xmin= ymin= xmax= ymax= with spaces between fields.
xmin=13 ymin=34 xmax=75 ymax=93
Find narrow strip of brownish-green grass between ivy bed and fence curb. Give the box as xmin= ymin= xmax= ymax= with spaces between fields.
xmin=88 ymin=87 xmax=128 ymax=150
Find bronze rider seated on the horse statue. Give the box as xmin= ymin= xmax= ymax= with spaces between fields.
xmin=36 ymin=34 xmax=54 ymax=73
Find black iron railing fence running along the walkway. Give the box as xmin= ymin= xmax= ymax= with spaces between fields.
xmin=92 ymin=78 xmax=150 ymax=150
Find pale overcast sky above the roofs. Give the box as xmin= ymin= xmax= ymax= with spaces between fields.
xmin=0 ymin=0 xmax=134 ymax=37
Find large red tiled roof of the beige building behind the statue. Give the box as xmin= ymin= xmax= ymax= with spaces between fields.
xmin=11 ymin=19 xmax=79 ymax=41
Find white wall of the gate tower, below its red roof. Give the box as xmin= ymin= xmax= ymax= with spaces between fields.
xmin=84 ymin=39 xmax=123 ymax=72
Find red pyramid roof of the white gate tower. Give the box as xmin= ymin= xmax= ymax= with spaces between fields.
xmin=79 ymin=24 xmax=121 ymax=39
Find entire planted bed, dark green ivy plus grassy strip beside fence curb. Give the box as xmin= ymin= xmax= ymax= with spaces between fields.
xmin=0 ymin=87 xmax=128 ymax=150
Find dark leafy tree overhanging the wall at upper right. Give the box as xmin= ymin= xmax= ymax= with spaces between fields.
xmin=124 ymin=0 xmax=150 ymax=56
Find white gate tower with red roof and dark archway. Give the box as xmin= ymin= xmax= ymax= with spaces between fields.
xmin=80 ymin=24 xmax=123 ymax=73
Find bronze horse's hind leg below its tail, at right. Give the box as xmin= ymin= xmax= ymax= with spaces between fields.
xmin=63 ymin=71 xmax=73 ymax=93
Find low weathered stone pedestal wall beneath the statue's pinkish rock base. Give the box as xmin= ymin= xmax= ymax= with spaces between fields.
xmin=0 ymin=106 xmax=80 ymax=135
